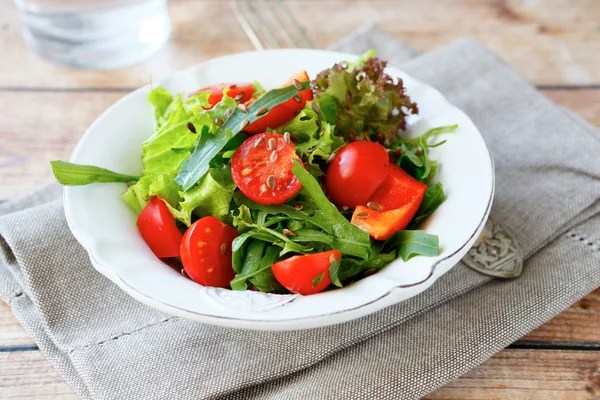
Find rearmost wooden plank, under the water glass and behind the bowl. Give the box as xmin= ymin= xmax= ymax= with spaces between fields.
xmin=0 ymin=0 xmax=600 ymax=87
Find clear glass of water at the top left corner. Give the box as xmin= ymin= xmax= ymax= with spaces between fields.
xmin=15 ymin=0 xmax=171 ymax=69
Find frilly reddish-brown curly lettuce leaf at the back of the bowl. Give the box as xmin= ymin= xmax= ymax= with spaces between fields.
xmin=312 ymin=52 xmax=418 ymax=144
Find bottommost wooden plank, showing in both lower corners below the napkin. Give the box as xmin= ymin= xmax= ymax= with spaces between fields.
xmin=0 ymin=350 xmax=600 ymax=400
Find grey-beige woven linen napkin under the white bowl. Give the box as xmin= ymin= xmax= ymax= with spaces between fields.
xmin=0 ymin=27 xmax=600 ymax=399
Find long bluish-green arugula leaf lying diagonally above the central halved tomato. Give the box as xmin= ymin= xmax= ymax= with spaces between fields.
xmin=175 ymin=81 xmax=310 ymax=192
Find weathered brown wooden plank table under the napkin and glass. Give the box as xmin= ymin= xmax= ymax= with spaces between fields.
xmin=0 ymin=0 xmax=600 ymax=400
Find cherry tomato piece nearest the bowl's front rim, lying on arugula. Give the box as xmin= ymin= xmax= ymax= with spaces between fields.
xmin=271 ymin=250 xmax=341 ymax=295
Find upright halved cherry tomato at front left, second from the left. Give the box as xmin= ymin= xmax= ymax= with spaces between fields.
xmin=181 ymin=217 xmax=238 ymax=288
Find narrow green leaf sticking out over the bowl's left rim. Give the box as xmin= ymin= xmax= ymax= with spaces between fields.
xmin=50 ymin=161 xmax=140 ymax=186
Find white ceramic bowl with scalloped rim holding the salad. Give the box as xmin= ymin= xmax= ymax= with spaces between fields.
xmin=65 ymin=50 xmax=494 ymax=330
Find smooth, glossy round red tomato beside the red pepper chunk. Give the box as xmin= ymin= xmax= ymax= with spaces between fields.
xmin=325 ymin=140 xmax=390 ymax=208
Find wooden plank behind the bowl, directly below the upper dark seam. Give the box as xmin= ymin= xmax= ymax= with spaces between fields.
xmin=0 ymin=89 xmax=600 ymax=200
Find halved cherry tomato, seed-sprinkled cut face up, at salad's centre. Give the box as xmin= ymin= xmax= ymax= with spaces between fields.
xmin=231 ymin=132 xmax=302 ymax=204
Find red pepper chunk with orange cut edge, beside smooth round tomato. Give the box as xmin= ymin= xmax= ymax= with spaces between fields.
xmin=351 ymin=164 xmax=427 ymax=240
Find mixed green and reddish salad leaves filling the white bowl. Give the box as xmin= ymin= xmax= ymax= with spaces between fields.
xmin=51 ymin=50 xmax=458 ymax=293
